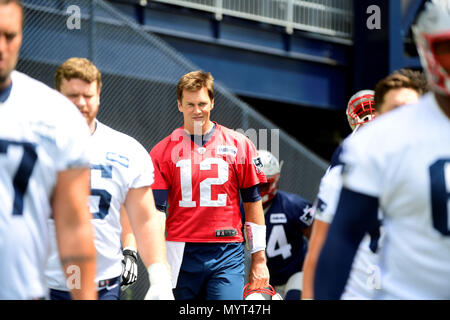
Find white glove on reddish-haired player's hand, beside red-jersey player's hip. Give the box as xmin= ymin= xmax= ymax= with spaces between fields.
xmin=144 ymin=263 xmax=175 ymax=300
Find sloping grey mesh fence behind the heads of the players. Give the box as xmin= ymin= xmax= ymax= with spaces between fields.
xmin=18 ymin=0 xmax=327 ymax=299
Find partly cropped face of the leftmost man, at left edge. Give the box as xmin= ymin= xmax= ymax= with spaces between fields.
xmin=0 ymin=3 xmax=22 ymax=89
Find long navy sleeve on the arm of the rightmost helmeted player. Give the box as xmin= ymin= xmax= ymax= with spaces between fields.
xmin=314 ymin=188 xmax=378 ymax=300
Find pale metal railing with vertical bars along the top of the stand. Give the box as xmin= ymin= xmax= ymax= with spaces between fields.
xmin=152 ymin=0 xmax=353 ymax=39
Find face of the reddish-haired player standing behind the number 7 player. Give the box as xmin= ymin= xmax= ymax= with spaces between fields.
xmin=60 ymin=78 xmax=100 ymax=133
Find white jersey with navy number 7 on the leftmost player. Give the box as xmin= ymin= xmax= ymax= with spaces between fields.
xmin=0 ymin=71 xmax=89 ymax=300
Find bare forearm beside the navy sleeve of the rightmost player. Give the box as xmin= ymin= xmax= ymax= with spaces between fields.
xmin=302 ymin=219 xmax=330 ymax=299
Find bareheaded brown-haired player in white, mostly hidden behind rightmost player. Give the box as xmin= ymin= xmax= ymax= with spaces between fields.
xmin=303 ymin=69 xmax=427 ymax=299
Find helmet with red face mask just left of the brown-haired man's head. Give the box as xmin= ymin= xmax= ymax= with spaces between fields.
xmin=346 ymin=90 xmax=375 ymax=131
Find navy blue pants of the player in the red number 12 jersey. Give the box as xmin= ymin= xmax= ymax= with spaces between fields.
xmin=174 ymin=243 xmax=244 ymax=300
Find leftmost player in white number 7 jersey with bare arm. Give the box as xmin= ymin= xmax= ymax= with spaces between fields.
xmin=0 ymin=0 xmax=96 ymax=300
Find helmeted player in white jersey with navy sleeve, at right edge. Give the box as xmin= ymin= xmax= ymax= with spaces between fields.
xmin=315 ymin=2 xmax=450 ymax=299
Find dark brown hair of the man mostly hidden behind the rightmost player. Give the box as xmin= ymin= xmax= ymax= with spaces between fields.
xmin=375 ymin=69 xmax=429 ymax=111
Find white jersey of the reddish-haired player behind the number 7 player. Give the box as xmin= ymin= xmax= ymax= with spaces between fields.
xmin=46 ymin=121 xmax=153 ymax=291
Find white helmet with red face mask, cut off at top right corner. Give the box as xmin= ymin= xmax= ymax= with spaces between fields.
xmin=412 ymin=0 xmax=450 ymax=95
